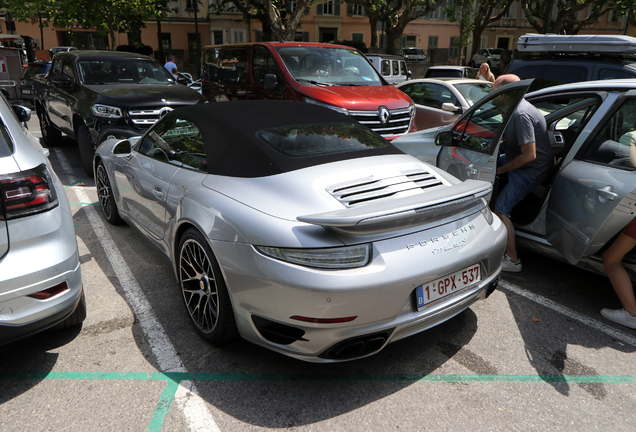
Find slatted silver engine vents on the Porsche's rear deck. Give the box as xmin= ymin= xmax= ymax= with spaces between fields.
xmin=327 ymin=170 xmax=445 ymax=207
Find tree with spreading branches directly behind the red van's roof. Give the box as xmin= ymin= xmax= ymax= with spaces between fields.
xmin=210 ymin=0 xmax=324 ymax=41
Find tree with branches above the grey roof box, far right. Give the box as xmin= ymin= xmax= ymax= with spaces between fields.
xmin=520 ymin=0 xmax=620 ymax=35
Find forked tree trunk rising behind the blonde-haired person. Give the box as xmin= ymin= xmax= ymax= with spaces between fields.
xmin=446 ymin=0 xmax=514 ymax=64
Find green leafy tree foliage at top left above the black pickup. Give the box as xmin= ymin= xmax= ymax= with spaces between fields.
xmin=0 ymin=0 xmax=168 ymax=47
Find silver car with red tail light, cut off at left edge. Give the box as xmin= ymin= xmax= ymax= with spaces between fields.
xmin=0 ymin=95 xmax=86 ymax=345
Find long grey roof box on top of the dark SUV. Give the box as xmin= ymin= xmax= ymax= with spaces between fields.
xmin=517 ymin=33 xmax=636 ymax=55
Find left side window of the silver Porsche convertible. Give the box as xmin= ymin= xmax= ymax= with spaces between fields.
xmin=137 ymin=118 xmax=208 ymax=172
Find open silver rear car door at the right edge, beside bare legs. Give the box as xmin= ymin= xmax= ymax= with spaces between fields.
xmin=546 ymin=90 xmax=636 ymax=264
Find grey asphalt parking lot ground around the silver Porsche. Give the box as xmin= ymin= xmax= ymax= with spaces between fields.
xmin=0 ymin=113 xmax=636 ymax=432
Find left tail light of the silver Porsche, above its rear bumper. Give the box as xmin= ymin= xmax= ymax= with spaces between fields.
xmin=254 ymin=243 xmax=371 ymax=269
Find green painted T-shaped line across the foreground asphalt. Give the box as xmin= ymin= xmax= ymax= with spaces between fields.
xmin=0 ymin=371 xmax=636 ymax=432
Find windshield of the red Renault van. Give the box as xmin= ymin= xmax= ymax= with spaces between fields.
xmin=275 ymin=46 xmax=383 ymax=86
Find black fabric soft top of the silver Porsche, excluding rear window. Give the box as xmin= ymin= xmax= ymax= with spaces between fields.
xmin=165 ymin=101 xmax=402 ymax=177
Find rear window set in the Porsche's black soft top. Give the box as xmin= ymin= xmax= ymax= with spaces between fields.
xmin=256 ymin=123 xmax=388 ymax=157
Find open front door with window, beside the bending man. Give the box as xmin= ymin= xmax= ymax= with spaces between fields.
xmin=435 ymin=79 xmax=532 ymax=184
